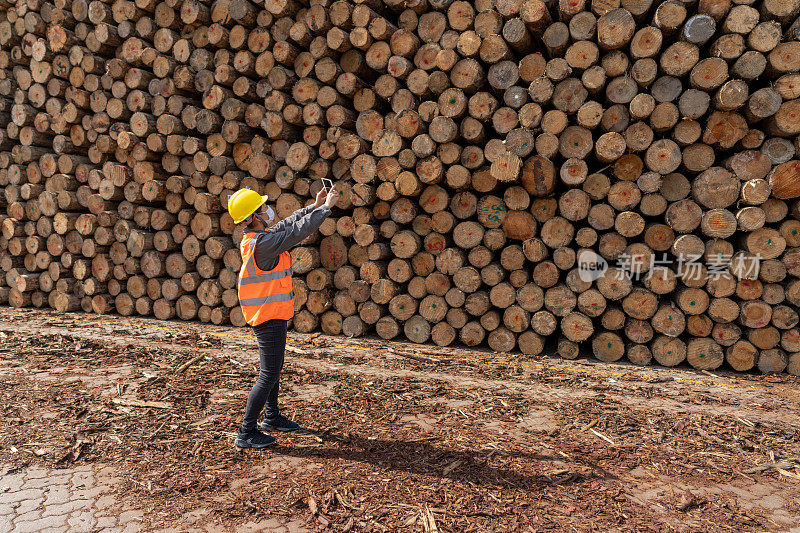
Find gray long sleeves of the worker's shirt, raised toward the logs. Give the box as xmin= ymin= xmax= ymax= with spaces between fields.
xmin=255 ymin=205 xmax=331 ymax=270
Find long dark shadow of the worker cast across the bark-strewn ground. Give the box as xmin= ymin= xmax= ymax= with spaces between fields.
xmin=274 ymin=432 xmax=607 ymax=489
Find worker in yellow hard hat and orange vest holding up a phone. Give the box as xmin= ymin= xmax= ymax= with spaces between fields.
xmin=228 ymin=185 xmax=339 ymax=448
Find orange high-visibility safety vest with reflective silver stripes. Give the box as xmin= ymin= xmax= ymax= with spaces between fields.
xmin=239 ymin=232 xmax=294 ymax=326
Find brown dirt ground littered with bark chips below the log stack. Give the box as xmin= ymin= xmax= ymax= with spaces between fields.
xmin=0 ymin=308 xmax=800 ymax=532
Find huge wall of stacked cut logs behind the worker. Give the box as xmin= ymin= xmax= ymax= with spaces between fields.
xmin=0 ymin=0 xmax=800 ymax=374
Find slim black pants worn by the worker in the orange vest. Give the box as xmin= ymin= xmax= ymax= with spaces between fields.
xmin=240 ymin=319 xmax=286 ymax=433
